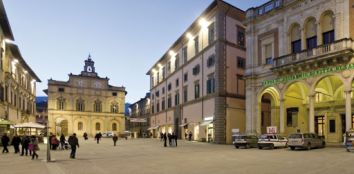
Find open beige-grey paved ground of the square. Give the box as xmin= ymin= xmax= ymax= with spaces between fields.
xmin=0 ymin=139 xmax=354 ymax=174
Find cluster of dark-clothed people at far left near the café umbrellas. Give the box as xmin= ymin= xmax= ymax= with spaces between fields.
xmin=1 ymin=133 xmax=39 ymax=160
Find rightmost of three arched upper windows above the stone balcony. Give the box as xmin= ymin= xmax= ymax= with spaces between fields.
xmin=321 ymin=11 xmax=335 ymax=45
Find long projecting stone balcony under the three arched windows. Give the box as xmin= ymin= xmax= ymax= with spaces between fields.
xmin=272 ymin=38 xmax=354 ymax=71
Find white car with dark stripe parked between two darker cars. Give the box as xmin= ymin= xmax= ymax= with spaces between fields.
xmin=258 ymin=134 xmax=288 ymax=149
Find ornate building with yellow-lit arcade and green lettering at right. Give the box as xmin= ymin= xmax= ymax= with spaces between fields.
xmin=245 ymin=0 xmax=354 ymax=142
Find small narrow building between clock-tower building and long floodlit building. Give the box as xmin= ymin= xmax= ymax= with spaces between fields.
xmin=129 ymin=93 xmax=150 ymax=138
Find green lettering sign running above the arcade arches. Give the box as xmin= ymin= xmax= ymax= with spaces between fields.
xmin=263 ymin=64 xmax=354 ymax=86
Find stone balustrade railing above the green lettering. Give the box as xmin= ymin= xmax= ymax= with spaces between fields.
xmin=273 ymin=38 xmax=354 ymax=69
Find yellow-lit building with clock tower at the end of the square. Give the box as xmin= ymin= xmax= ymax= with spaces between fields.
xmin=45 ymin=56 xmax=126 ymax=136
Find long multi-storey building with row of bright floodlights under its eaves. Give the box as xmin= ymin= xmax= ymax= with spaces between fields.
xmin=147 ymin=0 xmax=246 ymax=143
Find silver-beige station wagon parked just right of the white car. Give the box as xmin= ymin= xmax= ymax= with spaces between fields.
xmin=288 ymin=133 xmax=326 ymax=150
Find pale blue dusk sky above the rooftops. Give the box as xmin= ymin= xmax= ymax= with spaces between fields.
xmin=3 ymin=0 xmax=268 ymax=103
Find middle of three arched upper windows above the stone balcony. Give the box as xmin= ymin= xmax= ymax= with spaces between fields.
xmin=305 ymin=18 xmax=317 ymax=50
